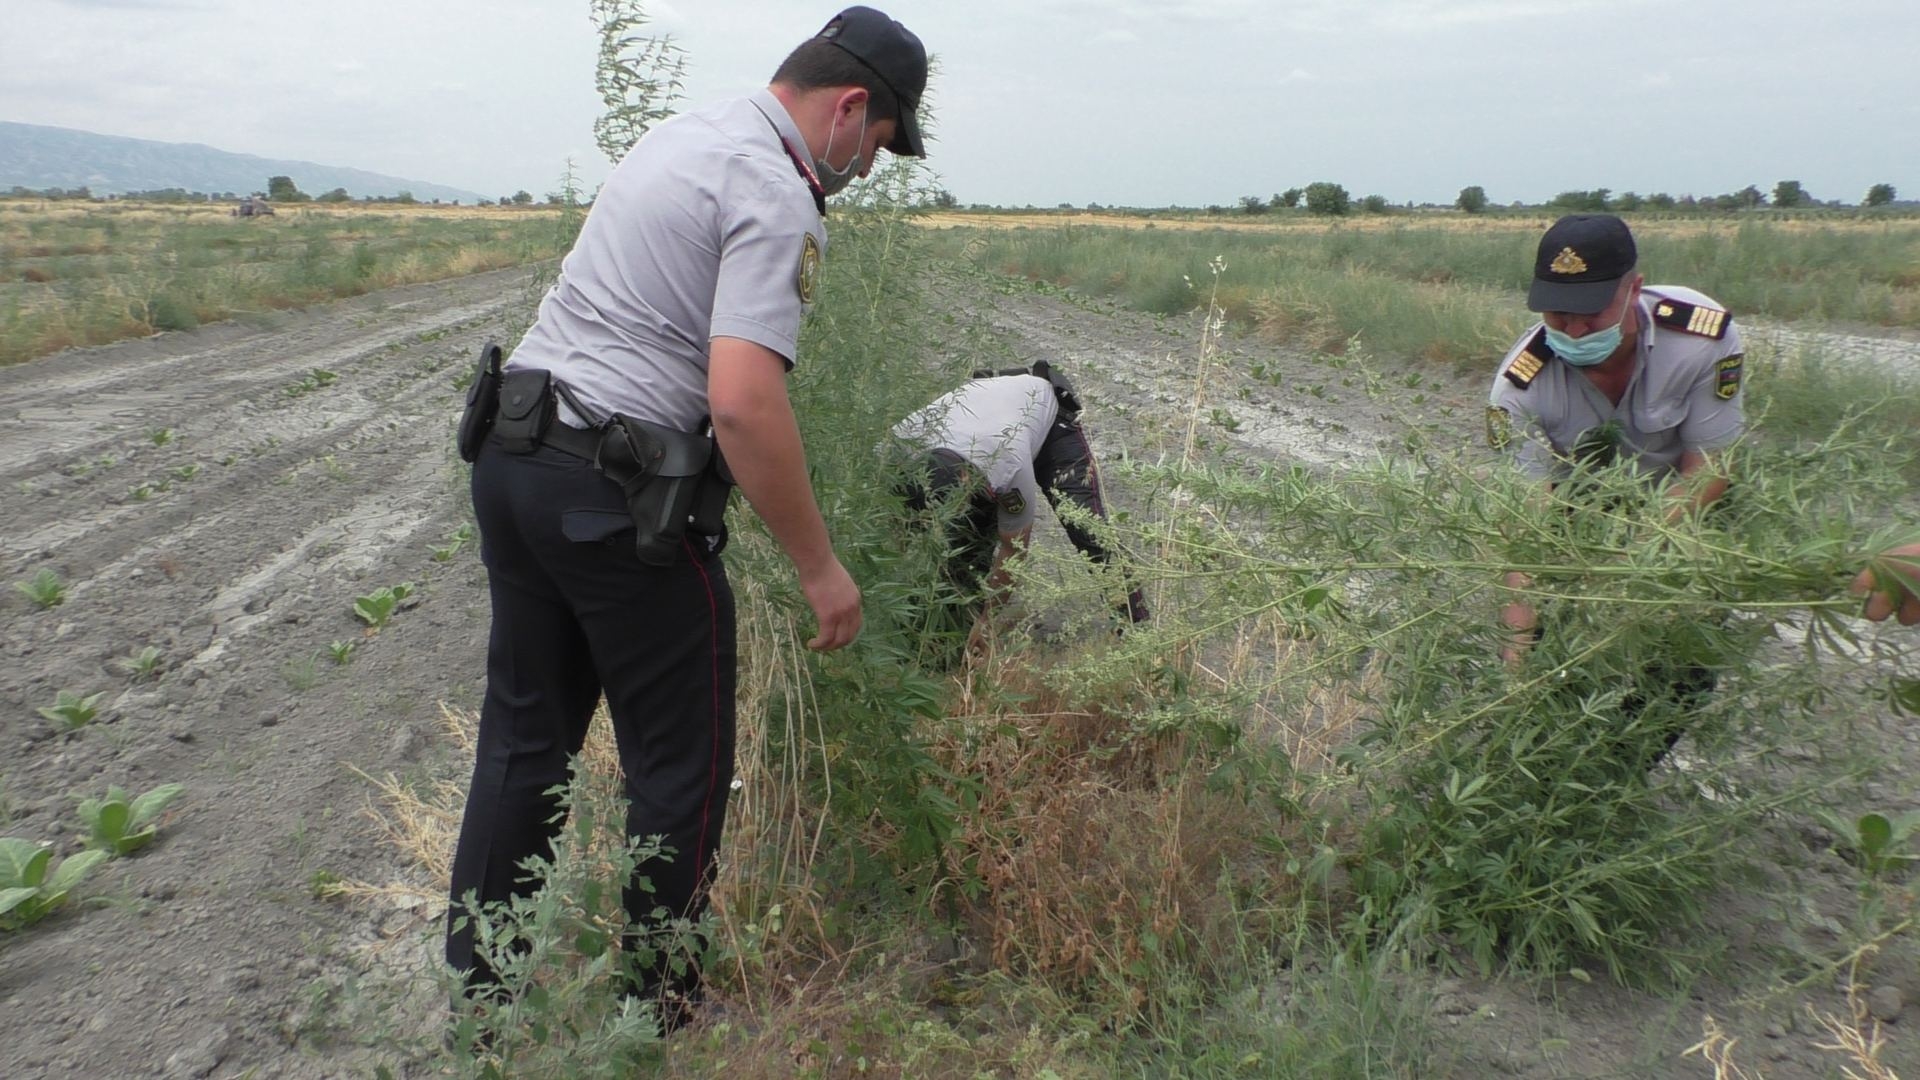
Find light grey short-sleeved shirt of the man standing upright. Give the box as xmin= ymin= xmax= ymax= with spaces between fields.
xmin=507 ymin=90 xmax=826 ymax=430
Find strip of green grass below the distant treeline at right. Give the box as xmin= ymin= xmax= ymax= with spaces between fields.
xmin=931 ymin=217 xmax=1920 ymax=367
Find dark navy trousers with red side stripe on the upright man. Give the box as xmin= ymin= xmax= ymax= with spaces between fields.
xmin=447 ymin=434 xmax=735 ymax=990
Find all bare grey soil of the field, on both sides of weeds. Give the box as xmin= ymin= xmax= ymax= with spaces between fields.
xmin=0 ymin=263 xmax=1920 ymax=1080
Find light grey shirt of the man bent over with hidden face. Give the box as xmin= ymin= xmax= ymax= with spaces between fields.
xmin=893 ymin=375 xmax=1060 ymax=536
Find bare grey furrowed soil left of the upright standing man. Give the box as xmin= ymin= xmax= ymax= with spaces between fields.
xmin=0 ymin=271 xmax=526 ymax=1078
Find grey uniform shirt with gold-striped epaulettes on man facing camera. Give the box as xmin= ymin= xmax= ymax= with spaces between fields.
xmin=1488 ymin=284 xmax=1745 ymax=480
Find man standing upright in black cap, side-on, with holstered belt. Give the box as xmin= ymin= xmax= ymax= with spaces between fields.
xmin=447 ymin=8 xmax=927 ymax=1024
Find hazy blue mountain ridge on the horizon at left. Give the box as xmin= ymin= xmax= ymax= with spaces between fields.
xmin=0 ymin=121 xmax=482 ymax=204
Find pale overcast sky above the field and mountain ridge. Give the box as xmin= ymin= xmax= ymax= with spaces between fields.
xmin=0 ymin=0 xmax=1920 ymax=206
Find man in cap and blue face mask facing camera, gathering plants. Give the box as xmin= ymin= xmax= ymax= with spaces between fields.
xmin=1486 ymin=213 xmax=1745 ymax=661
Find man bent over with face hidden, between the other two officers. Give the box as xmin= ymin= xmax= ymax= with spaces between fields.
xmin=893 ymin=359 xmax=1148 ymax=644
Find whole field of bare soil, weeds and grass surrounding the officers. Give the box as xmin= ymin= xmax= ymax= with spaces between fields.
xmin=11 ymin=203 xmax=1920 ymax=1080
